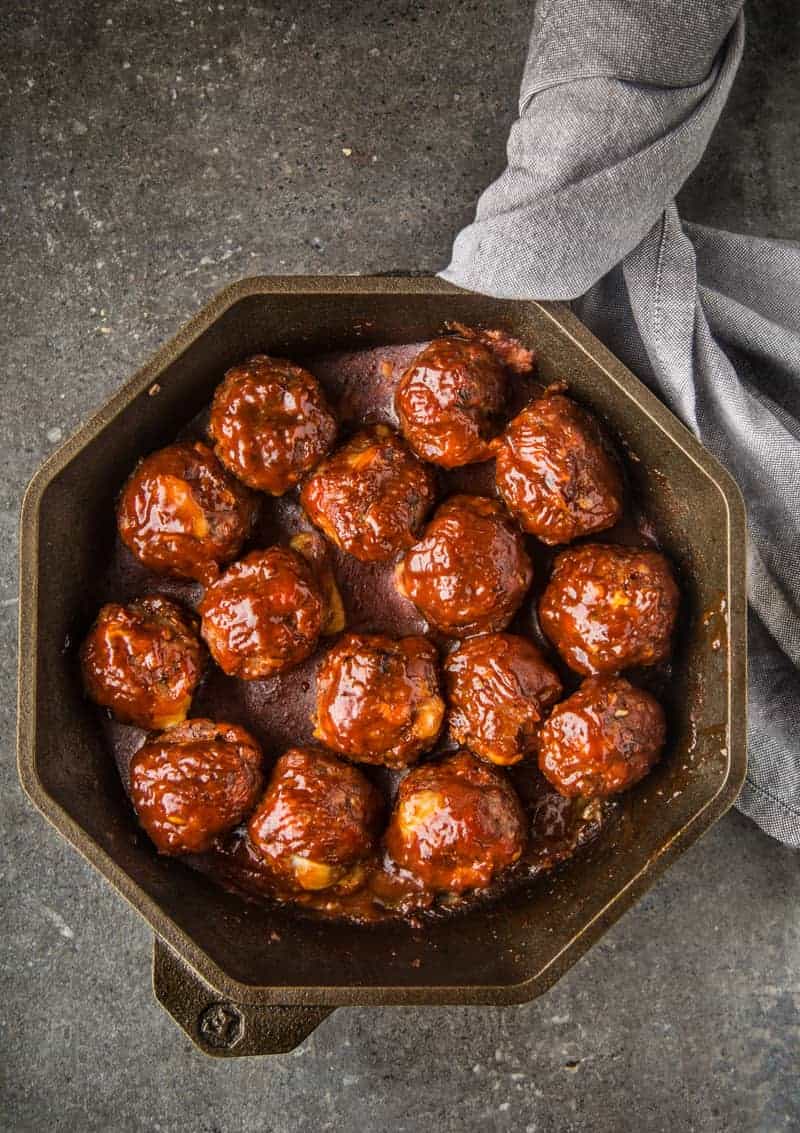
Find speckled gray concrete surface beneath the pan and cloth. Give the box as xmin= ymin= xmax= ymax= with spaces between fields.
xmin=0 ymin=0 xmax=800 ymax=1133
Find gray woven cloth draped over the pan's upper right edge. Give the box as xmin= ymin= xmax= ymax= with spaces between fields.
xmin=442 ymin=0 xmax=800 ymax=846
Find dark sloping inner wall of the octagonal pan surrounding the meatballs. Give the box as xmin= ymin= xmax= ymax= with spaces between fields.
xmin=26 ymin=281 xmax=731 ymax=989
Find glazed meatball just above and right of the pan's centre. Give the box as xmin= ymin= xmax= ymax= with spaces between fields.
xmin=395 ymin=495 xmax=533 ymax=637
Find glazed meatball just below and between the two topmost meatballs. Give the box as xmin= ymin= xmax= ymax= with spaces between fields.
xmin=300 ymin=425 xmax=435 ymax=562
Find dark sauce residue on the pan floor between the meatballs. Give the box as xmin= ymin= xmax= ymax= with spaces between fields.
xmin=91 ymin=343 xmax=669 ymax=922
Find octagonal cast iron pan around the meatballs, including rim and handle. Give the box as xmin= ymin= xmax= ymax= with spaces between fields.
xmin=18 ymin=276 xmax=746 ymax=1056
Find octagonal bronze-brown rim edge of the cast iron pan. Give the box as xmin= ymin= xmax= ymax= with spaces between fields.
xmin=17 ymin=275 xmax=747 ymax=1006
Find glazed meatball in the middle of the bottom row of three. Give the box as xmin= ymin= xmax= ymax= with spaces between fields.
xmin=248 ymin=748 xmax=383 ymax=891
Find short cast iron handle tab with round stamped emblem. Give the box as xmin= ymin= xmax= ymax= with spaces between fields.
xmin=153 ymin=936 xmax=333 ymax=1058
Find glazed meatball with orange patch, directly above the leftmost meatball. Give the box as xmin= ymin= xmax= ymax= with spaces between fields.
xmin=118 ymin=442 xmax=254 ymax=583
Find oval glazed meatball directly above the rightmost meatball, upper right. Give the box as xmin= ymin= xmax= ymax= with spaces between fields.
xmin=495 ymin=393 xmax=622 ymax=544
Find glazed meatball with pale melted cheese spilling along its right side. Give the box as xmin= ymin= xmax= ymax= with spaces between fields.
xmin=199 ymin=547 xmax=325 ymax=681
